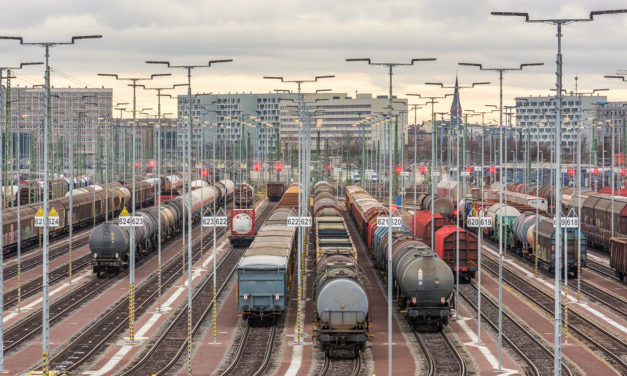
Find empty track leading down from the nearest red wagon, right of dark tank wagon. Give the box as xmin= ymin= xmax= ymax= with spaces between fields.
xmin=459 ymin=283 xmax=572 ymax=376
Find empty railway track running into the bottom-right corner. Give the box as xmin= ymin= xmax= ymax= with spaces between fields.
xmin=482 ymin=257 xmax=627 ymax=374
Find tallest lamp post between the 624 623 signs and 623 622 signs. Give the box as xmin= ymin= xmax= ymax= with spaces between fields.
xmin=146 ymin=59 xmax=233 ymax=374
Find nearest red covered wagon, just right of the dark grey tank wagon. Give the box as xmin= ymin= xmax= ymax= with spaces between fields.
xmin=433 ymin=225 xmax=477 ymax=279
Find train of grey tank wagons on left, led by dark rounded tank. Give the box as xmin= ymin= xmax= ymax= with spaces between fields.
xmin=89 ymin=180 xmax=233 ymax=277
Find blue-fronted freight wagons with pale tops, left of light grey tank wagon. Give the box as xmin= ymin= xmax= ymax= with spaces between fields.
xmin=236 ymin=208 xmax=297 ymax=319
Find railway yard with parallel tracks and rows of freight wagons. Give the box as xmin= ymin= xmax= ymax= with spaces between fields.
xmin=3 ymin=180 xmax=627 ymax=375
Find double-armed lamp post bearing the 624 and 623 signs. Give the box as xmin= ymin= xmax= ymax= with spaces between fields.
xmin=98 ymin=73 xmax=170 ymax=343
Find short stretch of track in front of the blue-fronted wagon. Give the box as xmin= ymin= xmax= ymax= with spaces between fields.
xmin=220 ymin=320 xmax=277 ymax=376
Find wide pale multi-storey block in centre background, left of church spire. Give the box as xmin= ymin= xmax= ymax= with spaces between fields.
xmin=177 ymin=93 xmax=407 ymax=159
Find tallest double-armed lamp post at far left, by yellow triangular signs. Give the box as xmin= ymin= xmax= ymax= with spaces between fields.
xmin=0 ymin=35 xmax=102 ymax=376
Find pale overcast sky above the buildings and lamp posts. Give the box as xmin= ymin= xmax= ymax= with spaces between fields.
xmin=0 ymin=0 xmax=627 ymax=119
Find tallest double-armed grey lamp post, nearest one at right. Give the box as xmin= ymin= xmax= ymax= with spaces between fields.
xmin=491 ymin=9 xmax=627 ymax=375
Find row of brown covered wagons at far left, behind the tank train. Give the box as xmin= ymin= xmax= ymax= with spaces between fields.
xmin=2 ymin=181 xmax=154 ymax=253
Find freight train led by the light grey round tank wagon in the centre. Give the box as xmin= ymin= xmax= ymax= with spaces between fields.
xmin=312 ymin=182 xmax=371 ymax=356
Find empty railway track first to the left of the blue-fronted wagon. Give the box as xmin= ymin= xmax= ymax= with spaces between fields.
xmin=122 ymin=201 xmax=276 ymax=376
